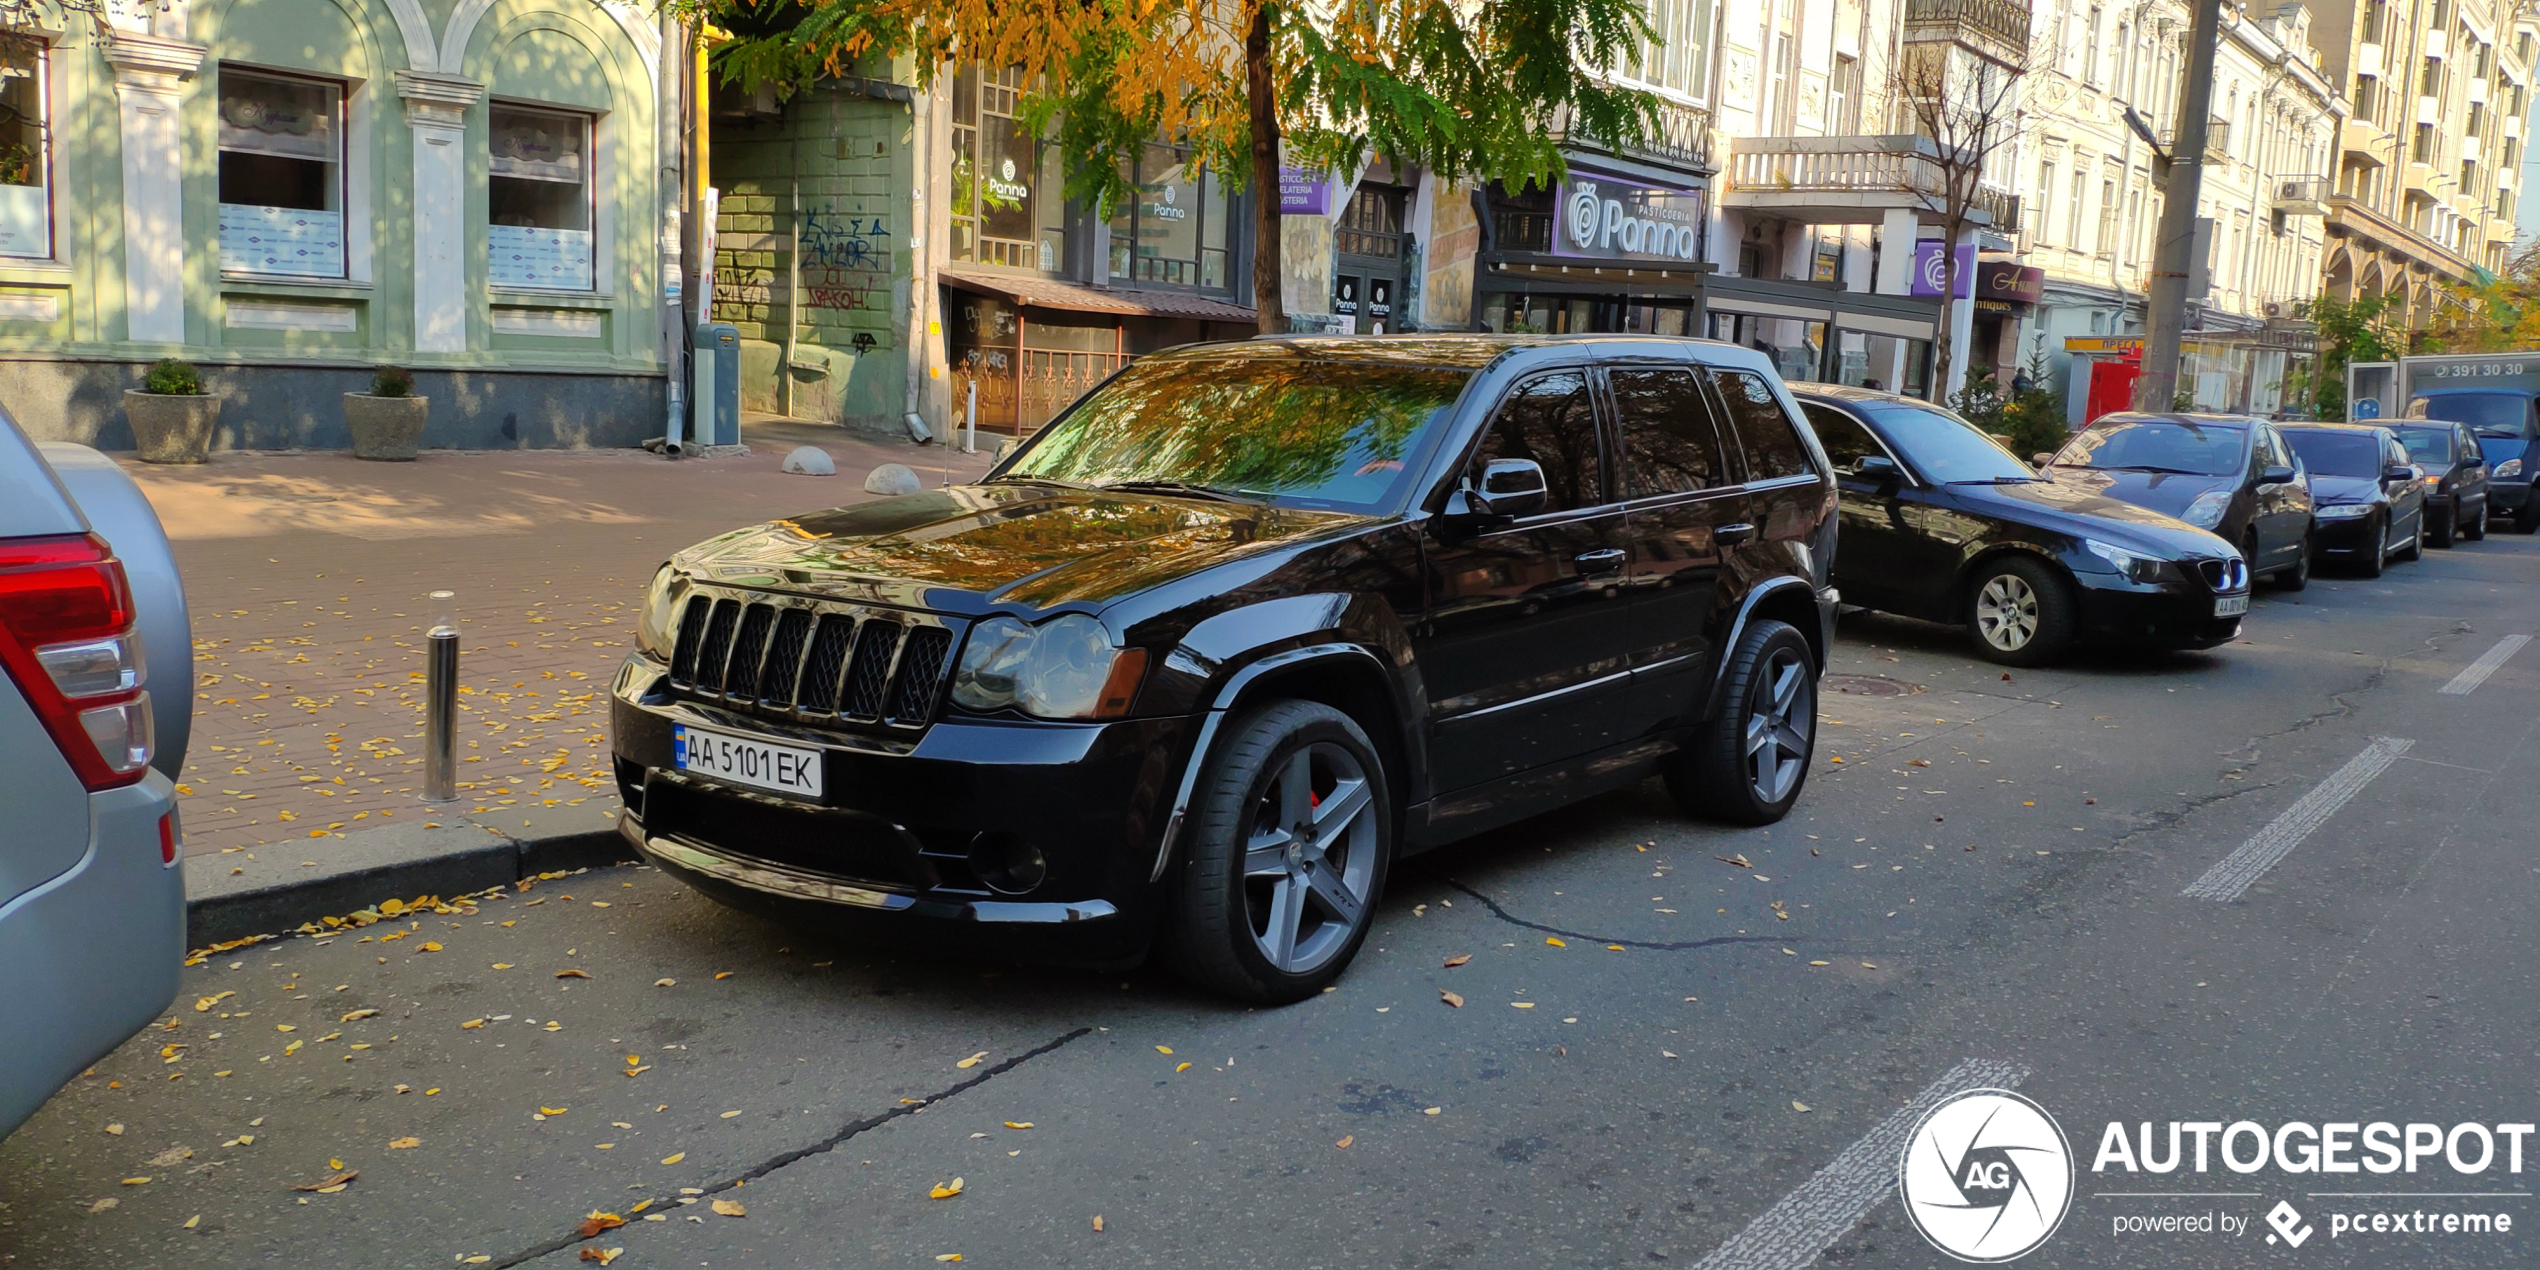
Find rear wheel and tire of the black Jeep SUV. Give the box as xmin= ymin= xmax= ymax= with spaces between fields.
xmin=1661 ymin=620 xmax=1816 ymax=826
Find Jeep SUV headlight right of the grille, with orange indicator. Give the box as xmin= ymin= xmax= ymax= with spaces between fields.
xmin=953 ymin=612 xmax=1146 ymax=719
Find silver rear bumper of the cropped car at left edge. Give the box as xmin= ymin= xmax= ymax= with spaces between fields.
xmin=0 ymin=772 xmax=185 ymax=1135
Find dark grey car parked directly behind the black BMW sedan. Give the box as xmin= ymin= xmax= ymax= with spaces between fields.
xmin=2037 ymin=414 xmax=2311 ymax=592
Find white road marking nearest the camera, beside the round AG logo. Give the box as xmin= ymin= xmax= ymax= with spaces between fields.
xmin=1694 ymin=1059 xmax=2029 ymax=1270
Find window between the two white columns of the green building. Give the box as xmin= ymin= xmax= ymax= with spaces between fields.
xmin=221 ymin=66 xmax=345 ymax=277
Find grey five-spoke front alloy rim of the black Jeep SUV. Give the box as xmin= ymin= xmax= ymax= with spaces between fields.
xmin=1245 ymin=742 xmax=1379 ymax=975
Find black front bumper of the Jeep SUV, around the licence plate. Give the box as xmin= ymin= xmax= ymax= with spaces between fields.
xmin=612 ymin=658 xmax=1201 ymax=963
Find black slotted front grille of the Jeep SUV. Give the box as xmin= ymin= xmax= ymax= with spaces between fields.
xmin=671 ymin=589 xmax=955 ymax=729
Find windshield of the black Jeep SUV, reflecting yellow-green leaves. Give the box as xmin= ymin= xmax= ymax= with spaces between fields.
xmin=996 ymin=358 xmax=1471 ymax=511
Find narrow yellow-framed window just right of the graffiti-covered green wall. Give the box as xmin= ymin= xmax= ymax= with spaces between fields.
xmin=950 ymin=64 xmax=1067 ymax=272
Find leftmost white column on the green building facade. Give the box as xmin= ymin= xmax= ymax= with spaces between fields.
xmin=107 ymin=30 xmax=203 ymax=343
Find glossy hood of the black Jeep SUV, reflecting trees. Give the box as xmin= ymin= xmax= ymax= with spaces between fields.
xmin=673 ymin=485 xmax=1377 ymax=612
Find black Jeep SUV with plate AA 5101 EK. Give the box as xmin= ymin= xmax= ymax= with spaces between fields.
xmin=612 ymin=335 xmax=1836 ymax=1001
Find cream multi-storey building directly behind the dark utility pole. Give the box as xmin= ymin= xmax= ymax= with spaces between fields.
xmin=1996 ymin=0 xmax=2344 ymax=422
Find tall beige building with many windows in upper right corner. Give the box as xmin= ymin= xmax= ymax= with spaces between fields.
xmin=2314 ymin=0 xmax=2535 ymax=328
